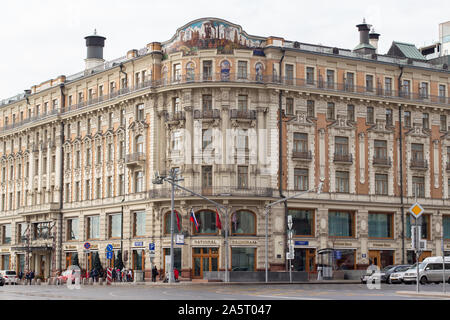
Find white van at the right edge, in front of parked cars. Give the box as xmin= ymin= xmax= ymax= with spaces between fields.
xmin=403 ymin=257 xmax=450 ymax=284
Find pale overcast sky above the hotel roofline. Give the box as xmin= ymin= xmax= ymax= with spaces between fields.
xmin=0 ymin=0 xmax=450 ymax=100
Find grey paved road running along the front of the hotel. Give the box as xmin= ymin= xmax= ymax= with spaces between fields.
xmin=0 ymin=284 xmax=450 ymax=301
